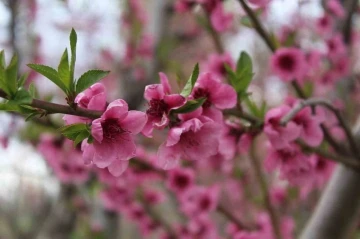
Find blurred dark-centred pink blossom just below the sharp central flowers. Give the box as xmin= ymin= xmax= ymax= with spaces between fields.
xmin=167 ymin=168 xmax=195 ymax=194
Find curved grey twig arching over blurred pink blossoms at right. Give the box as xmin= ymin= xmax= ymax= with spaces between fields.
xmin=280 ymin=98 xmax=360 ymax=157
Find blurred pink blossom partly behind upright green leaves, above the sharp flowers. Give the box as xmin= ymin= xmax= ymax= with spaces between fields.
xmin=203 ymin=53 xmax=235 ymax=79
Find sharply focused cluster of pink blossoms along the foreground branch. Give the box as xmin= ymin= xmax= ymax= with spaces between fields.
xmin=58 ymin=66 xmax=237 ymax=176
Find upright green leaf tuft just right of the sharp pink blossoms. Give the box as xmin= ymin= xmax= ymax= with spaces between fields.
xmin=225 ymin=51 xmax=254 ymax=100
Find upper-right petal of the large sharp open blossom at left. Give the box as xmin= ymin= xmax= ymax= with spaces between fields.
xmin=120 ymin=110 xmax=147 ymax=134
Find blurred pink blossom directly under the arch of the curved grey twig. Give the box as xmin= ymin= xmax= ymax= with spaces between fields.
xmin=292 ymin=107 xmax=324 ymax=147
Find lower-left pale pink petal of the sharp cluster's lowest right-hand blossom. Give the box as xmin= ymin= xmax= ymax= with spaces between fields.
xmin=156 ymin=144 xmax=180 ymax=170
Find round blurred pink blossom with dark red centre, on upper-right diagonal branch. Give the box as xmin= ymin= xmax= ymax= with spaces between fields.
xmin=270 ymin=47 xmax=307 ymax=82
